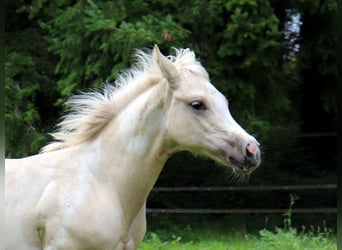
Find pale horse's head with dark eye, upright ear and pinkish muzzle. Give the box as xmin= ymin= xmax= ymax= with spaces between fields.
xmin=153 ymin=46 xmax=260 ymax=174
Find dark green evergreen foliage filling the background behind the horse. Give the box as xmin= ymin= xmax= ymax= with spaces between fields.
xmin=5 ymin=0 xmax=336 ymax=191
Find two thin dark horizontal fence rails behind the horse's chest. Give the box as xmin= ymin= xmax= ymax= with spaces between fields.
xmin=146 ymin=184 xmax=337 ymax=214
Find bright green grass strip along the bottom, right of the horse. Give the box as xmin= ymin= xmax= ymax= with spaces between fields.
xmin=139 ymin=227 xmax=337 ymax=250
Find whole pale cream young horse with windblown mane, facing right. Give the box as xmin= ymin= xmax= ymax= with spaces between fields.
xmin=5 ymin=45 xmax=260 ymax=250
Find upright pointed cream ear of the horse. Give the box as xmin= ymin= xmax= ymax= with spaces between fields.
xmin=153 ymin=45 xmax=179 ymax=88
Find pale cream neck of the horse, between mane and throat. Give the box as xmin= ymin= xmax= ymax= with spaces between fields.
xmin=98 ymin=80 xmax=173 ymax=214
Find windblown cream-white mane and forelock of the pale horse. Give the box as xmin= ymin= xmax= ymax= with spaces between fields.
xmin=40 ymin=48 xmax=209 ymax=153
